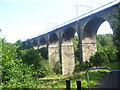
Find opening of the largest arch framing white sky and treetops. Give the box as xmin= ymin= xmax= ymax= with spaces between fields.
xmin=96 ymin=21 xmax=114 ymax=51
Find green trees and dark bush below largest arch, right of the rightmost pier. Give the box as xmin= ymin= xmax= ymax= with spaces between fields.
xmin=90 ymin=34 xmax=117 ymax=66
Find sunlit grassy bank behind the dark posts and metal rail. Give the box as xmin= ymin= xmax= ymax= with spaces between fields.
xmin=39 ymin=62 xmax=120 ymax=88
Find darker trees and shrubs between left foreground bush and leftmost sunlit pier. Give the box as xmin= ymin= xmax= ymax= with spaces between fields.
xmin=15 ymin=40 xmax=52 ymax=78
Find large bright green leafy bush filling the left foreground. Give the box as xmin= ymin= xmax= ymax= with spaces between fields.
xmin=2 ymin=39 xmax=38 ymax=88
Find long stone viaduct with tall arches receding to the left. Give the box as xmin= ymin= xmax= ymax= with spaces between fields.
xmin=23 ymin=3 xmax=118 ymax=75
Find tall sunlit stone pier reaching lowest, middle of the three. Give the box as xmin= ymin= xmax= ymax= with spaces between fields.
xmin=61 ymin=39 xmax=75 ymax=75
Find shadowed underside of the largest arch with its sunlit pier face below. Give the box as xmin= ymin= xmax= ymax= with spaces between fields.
xmin=82 ymin=17 xmax=113 ymax=61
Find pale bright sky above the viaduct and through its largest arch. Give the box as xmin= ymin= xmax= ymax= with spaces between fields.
xmin=0 ymin=0 xmax=118 ymax=43
